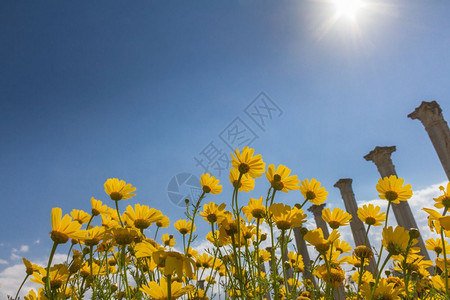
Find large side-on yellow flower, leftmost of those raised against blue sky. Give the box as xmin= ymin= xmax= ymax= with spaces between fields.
xmin=50 ymin=207 xmax=84 ymax=244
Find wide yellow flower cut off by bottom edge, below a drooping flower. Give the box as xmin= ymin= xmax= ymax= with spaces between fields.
xmin=139 ymin=277 xmax=195 ymax=300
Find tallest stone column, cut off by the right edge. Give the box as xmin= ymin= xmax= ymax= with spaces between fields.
xmin=408 ymin=101 xmax=450 ymax=180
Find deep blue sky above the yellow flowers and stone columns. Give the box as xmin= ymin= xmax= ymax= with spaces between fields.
xmin=0 ymin=0 xmax=450 ymax=292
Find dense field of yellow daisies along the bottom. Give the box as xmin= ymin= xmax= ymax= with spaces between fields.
xmin=12 ymin=147 xmax=450 ymax=300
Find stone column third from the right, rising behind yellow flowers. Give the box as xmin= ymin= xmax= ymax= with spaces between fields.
xmin=334 ymin=178 xmax=376 ymax=274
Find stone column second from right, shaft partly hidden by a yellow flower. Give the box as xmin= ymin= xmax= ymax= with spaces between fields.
xmin=364 ymin=146 xmax=430 ymax=260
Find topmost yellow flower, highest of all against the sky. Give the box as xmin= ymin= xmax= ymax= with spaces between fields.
xmin=231 ymin=147 xmax=266 ymax=178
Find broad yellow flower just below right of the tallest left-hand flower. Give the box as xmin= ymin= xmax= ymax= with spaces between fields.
xmin=123 ymin=203 xmax=162 ymax=229
